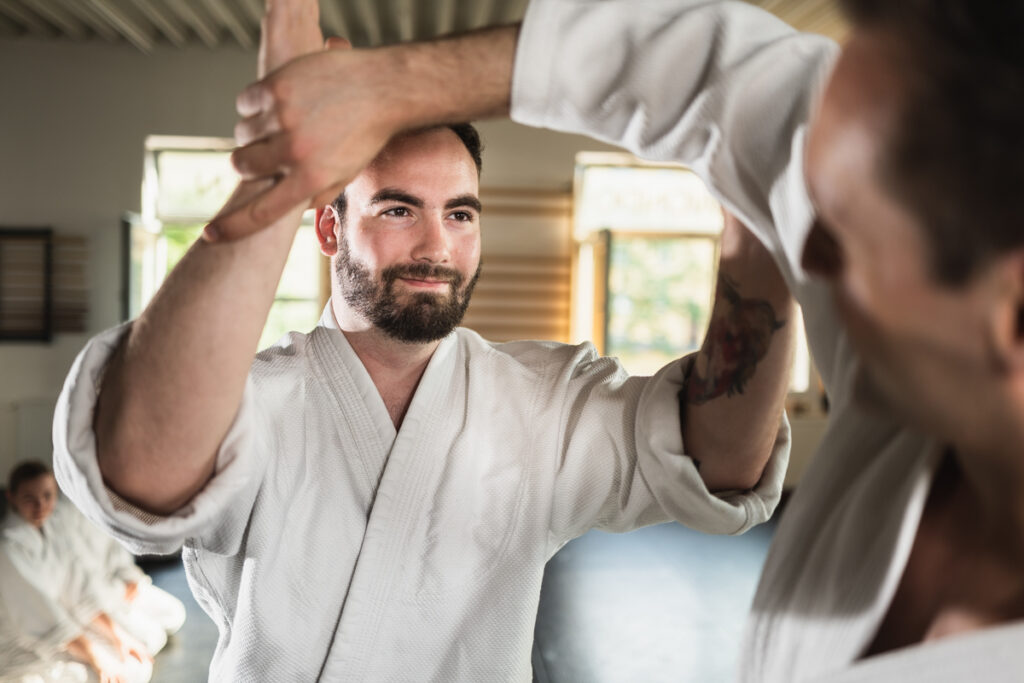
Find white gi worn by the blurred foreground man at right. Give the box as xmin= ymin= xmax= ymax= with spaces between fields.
xmin=512 ymin=0 xmax=1024 ymax=682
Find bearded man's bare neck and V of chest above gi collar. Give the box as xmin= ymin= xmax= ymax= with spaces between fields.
xmin=334 ymin=304 xmax=440 ymax=429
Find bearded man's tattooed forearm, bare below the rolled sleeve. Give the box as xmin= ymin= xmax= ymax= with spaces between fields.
xmin=680 ymin=216 xmax=797 ymax=490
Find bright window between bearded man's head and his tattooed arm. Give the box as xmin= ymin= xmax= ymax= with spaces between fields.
xmin=572 ymin=153 xmax=817 ymax=405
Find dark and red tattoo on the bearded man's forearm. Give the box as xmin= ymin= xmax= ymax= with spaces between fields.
xmin=680 ymin=273 xmax=785 ymax=405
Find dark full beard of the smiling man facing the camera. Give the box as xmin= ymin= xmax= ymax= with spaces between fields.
xmin=335 ymin=239 xmax=480 ymax=343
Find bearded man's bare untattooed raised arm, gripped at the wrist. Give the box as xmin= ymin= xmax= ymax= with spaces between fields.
xmin=94 ymin=0 xmax=323 ymax=514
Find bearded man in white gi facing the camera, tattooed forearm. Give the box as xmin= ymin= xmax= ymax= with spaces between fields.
xmin=54 ymin=0 xmax=793 ymax=681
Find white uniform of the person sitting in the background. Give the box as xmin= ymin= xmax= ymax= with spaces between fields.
xmin=0 ymin=513 xmax=153 ymax=683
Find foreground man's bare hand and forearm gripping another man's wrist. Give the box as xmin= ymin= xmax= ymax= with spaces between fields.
xmin=204 ymin=26 xmax=518 ymax=241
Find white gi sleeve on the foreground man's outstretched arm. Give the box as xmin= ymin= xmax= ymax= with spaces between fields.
xmin=511 ymin=0 xmax=838 ymax=282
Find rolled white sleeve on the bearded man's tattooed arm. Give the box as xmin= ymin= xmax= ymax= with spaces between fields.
xmin=550 ymin=344 xmax=790 ymax=550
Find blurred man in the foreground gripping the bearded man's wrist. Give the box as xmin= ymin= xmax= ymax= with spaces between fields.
xmin=208 ymin=0 xmax=1024 ymax=682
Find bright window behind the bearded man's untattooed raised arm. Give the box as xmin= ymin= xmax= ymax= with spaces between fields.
xmin=126 ymin=136 xmax=326 ymax=348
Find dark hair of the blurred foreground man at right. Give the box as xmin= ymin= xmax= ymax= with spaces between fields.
xmin=842 ymin=0 xmax=1024 ymax=286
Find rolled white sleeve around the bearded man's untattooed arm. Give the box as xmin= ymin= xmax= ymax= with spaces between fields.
xmin=53 ymin=323 xmax=267 ymax=555
